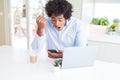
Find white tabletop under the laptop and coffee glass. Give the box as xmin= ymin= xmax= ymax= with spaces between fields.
xmin=0 ymin=46 xmax=120 ymax=80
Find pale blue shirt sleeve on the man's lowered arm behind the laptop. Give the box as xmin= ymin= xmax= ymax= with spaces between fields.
xmin=75 ymin=21 xmax=87 ymax=47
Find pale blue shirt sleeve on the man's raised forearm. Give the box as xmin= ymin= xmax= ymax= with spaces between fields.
xmin=31 ymin=33 xmax=46 ymax=51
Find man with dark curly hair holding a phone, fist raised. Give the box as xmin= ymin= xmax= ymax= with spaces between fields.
xmin=32 ymin=0 xmax=87 ymax=58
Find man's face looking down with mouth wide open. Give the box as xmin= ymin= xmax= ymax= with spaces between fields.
xmin=51 ymin=14 xmax=66 ymax=31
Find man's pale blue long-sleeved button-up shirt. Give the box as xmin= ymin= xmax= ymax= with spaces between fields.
xmin=32 ymin=17 xmax=87 ymax=50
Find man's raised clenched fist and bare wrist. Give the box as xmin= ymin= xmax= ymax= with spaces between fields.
xmin=36 ymin=16 xmax=46 ymax=36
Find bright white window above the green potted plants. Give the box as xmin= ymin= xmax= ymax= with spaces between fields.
xmin=95 ymin=2 xmax=120 ymax=22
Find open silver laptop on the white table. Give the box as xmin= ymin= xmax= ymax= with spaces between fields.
xmin=61 ymin=46 xmax=97 ymax=69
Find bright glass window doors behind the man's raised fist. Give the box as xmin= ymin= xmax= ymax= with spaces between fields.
xmin=11 ymin=0 xmax=46 ymax=49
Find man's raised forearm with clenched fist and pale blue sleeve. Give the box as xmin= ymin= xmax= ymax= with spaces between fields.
xmin=31 ymin=16 xmax=46 ymax=50
